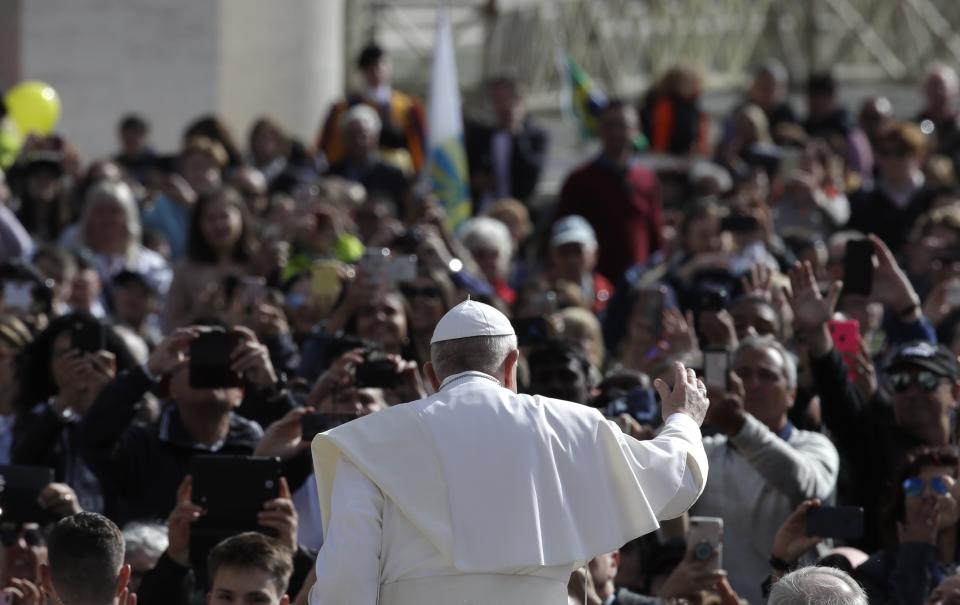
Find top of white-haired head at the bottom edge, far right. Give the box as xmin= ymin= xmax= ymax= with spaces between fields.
xmin=767 ymin=567 xmax=870 ymax=605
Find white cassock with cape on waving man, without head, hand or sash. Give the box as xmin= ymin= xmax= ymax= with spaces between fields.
xmin=310 ymin=375 xmax=707 ymax=605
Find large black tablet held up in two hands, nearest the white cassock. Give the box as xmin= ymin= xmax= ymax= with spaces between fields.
xmin=190 ymin=456 xmax=281 ymax=579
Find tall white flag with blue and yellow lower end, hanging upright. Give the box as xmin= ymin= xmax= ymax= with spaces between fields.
xmin=427 ymin=1 xmax=473 ymax=229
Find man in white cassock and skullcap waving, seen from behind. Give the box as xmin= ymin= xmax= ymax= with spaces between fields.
xmin=310 ymin=300 xmax=708 ymax=605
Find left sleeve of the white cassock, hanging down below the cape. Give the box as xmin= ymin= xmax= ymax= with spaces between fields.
xmin=310 ymin=458 xmax=383 ymax=605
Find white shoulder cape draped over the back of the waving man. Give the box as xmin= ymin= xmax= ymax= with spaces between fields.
xmin=313 ymin=378 xmax=706 ymax=573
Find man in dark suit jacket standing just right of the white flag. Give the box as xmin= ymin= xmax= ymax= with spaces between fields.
xmin=467 ymin=77 xmax=550 ymax=212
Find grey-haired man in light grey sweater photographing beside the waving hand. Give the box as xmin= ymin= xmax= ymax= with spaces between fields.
xmin=692 ymin=336 xmax=840 ymax=603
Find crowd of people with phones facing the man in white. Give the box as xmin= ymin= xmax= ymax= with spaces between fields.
xmin=0 ymin=40 xmax=960 ymax=605
